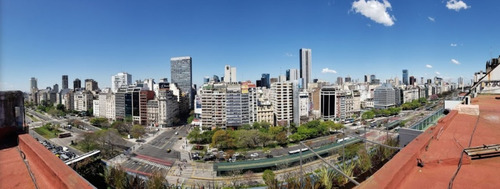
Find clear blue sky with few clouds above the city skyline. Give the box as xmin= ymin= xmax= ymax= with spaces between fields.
xmin=0 ymin=0 xmax=500 ymax=91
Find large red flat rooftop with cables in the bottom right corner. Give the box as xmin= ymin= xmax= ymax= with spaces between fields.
xmin=358 ymin=95 xmax=500 ymax=189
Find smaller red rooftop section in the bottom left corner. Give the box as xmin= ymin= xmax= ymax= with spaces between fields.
xmin=0 ymin=134 xmax=94 ymax=189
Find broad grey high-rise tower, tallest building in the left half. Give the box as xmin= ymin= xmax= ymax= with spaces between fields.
xmin=170 ymin=56 xmax=192 ymax=109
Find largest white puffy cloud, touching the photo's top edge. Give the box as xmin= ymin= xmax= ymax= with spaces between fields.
xmin=352 ymin=0 xmax=396 ymax=26
